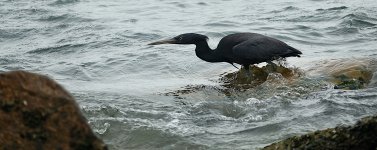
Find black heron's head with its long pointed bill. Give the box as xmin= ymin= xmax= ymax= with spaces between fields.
xmin=148 ymin=33 xmax=208 ymax=45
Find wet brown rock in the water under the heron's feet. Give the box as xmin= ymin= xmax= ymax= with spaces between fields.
xmin=164 ymin=64 xmax=304 ymax=99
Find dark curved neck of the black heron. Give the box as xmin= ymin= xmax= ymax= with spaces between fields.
xmin=195 ymin=41 xmax=224 ymax=62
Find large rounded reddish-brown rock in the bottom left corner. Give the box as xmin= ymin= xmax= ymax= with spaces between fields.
xmin=0 ymin=71 xmax=107 ymax=150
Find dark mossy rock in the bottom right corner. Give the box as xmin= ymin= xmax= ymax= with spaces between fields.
xmin=264 ymin=116 xmax=377 ymax=150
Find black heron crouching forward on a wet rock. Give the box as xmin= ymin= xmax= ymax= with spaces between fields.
xmin=148 ymin=33 xmax=302 ymax=74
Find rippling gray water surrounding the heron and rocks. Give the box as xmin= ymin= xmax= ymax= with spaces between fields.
xmin=0 ymin=0 xmax=377 ymax=150
